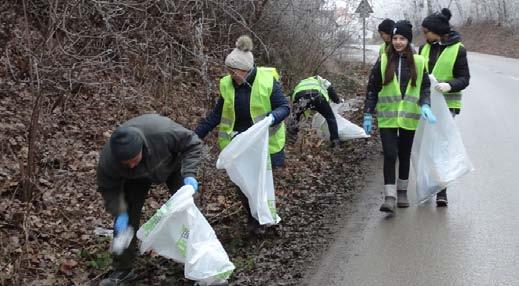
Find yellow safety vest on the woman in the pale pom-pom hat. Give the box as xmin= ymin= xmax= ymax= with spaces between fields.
xmin=218 ymin=67 xmax=285 ymax=154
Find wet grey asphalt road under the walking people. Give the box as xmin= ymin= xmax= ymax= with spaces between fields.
xmin=307 ymin=50 xmax=519 ymax=286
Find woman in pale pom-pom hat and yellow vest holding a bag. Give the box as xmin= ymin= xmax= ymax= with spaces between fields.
xmin=195 ymin=36 xmax=290 ymax=235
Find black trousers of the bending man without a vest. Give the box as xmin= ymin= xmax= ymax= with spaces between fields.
xmin=112 ymin=170 xmax=183 ymax=270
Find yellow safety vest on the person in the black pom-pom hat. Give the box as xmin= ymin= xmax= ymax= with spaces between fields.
xmin=420 ymin=43 xmax=463 ymax=109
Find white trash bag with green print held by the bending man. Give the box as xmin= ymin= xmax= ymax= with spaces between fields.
xmin=137 ymin=186 xmax=234 ymax=285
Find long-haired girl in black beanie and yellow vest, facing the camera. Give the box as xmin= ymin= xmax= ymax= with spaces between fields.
xmin=363 ymin=20 xmax=436 ymax=214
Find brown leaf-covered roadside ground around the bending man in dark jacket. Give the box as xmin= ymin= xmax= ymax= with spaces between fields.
xmin=0 ymin=52 xmax=376 ymax=286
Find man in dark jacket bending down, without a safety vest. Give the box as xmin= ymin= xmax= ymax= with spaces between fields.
xmin=97 ymin=114 xmax=202 ymax=286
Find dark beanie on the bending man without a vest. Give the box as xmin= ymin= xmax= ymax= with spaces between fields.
xmin=110 ymin=126 xmax=143 ymax=162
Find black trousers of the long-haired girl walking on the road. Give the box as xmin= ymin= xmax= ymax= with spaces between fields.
xmin=379 ymin=128 xmax=414 ymax=185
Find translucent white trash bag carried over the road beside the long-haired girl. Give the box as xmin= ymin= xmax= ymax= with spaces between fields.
xmin=411 ymin=76 xmax=474 ymax=202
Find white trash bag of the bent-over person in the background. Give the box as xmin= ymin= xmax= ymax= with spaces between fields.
xmin=312 ymin=103 xmax=369 ymax=141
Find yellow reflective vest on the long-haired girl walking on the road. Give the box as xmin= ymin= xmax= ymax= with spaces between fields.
xmin=377 ymin=54 xmax=425 ymax=130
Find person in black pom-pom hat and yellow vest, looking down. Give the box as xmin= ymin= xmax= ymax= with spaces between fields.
xmin=420 ymin=8 xmax=470 ymax=207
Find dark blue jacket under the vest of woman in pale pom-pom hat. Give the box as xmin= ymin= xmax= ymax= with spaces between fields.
xmin=195 ymin=67 xmax=290 ymax=166
